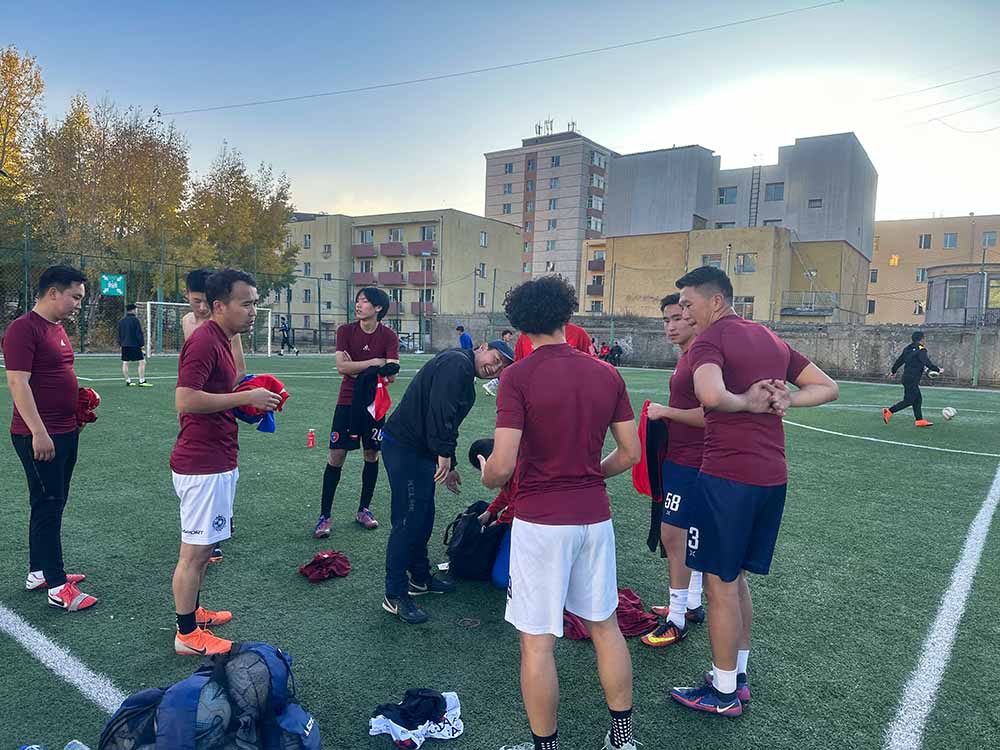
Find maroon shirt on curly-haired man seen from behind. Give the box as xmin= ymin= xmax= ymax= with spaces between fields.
xmin=497 ymin=344 xmax=634 ymax=526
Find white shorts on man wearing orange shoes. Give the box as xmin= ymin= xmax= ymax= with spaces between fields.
xmin=171 ymin=469 xmax=240 ymax=544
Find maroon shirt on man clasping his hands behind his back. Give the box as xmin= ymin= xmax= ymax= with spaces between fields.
xmin=687 ymin=315 xmax=809 ymax=487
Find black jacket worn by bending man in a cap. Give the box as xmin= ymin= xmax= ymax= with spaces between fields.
xmin=385 ymin=349 xmax=476 ymax=466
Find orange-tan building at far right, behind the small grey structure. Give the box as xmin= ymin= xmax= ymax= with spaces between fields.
xmin=865 ymin=214 xmax=1000 ymax=325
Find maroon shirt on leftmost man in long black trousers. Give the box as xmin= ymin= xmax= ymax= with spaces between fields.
xmin=0 ymin=310 xmax=79 ymax=435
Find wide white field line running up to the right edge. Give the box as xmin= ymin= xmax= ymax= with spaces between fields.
xmin=883 ymin=467 xmax=1000 ymax=750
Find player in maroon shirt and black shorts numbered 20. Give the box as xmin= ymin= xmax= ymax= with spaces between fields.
xmin=313 ymin=286 xmax=399 ymax=539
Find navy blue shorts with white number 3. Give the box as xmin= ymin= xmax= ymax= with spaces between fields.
xmin=686 ymin=473 xmax=786 ymax=582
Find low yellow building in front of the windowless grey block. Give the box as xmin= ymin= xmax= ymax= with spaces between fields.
xmin=578 ymin=226 xmax=868 ymax=323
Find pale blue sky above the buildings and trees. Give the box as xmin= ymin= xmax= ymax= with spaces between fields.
xmin=7 ymin=0 xmax=1000 ymax=219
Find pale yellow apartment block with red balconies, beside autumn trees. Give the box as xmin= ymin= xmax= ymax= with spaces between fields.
xmin=278 ymin=208 xmax=524 ymax=347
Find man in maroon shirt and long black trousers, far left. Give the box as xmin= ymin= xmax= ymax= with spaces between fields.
xmin=2 ymin=266 xmax=97 ymax=612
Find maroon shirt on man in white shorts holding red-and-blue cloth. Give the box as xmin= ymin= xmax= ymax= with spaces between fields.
xmin=170 ymin=320 xmax=240 ymax=474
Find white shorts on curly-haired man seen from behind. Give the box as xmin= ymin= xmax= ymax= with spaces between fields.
xmin=504 ymin=518 xmax=618 ymax=638
